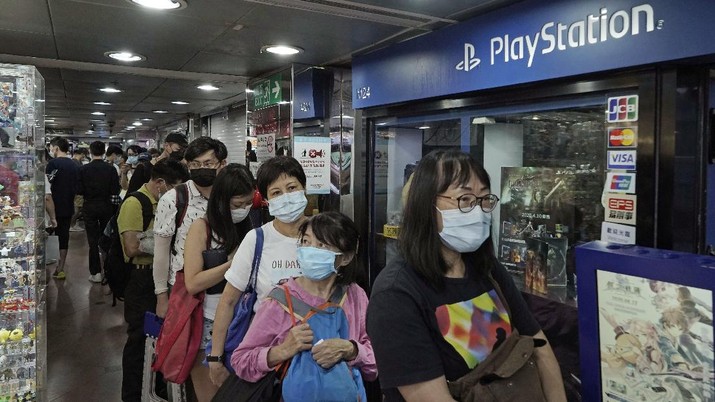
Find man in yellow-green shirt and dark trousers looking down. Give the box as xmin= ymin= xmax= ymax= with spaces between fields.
xmin=117 ymin=160 xmax=188 ymax=402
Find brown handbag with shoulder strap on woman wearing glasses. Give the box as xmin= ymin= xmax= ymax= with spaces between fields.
xmin=447 ymin=273 xmax=546 ymax=402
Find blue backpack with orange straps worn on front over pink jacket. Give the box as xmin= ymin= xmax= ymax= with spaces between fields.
xmin=268 ymin=285 xmax=367 ymax=402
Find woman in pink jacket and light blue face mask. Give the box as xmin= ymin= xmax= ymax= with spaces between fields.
xmin=231 ymin=212 xmax=377 ymax=388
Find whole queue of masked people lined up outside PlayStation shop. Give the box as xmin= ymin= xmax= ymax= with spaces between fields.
xmin=48 ymin=137 xmax=565 ymax=402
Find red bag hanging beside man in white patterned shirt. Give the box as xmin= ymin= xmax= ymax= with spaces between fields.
xmin=151 ymin=271 xmax=204 ymax=384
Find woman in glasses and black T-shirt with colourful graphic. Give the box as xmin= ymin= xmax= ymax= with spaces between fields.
xmin=367 ymin=151 xmax=566 ymax=402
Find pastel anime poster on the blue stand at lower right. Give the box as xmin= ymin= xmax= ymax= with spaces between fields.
xmin=597 ymin=270 xmax=715 ymax=402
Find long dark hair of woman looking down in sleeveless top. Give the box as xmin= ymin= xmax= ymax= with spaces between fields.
xmin=206 ymin=163 xmax=256 ymax=254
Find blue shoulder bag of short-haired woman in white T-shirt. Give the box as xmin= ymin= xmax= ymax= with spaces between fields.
xmin=203 ymin=227 xmax=263 ymax=374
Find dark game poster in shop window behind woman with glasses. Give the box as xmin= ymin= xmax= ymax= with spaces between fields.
xmin=498 ymin=167 xmax=576 ymax=293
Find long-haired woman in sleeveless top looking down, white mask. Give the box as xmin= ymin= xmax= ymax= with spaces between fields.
xmin=184 ymin=163 xmax=255 ymax=401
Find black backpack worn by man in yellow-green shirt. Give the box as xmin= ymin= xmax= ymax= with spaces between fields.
xmin=100 ymin=191 xmax=154 ymax=307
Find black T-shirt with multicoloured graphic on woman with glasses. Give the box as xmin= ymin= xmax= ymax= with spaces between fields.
xmin=367 ymin=260 xmax=540 ymax=402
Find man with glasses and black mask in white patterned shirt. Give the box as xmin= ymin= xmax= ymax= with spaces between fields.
xmin=154 ymin=137 xmax=228 ymax=317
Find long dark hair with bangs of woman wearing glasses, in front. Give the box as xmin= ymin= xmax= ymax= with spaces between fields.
xmin=398 ymin=150 xmax=496 ymax=289
